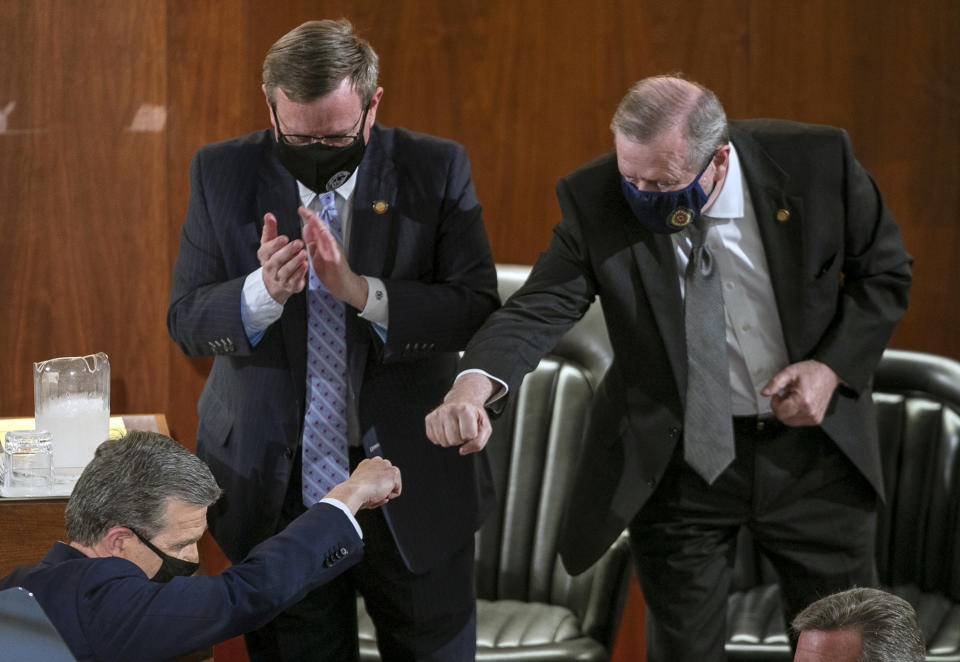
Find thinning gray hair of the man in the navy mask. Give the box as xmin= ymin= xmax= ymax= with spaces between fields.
xmin=610 ymin=75 xmax=730 ymax=170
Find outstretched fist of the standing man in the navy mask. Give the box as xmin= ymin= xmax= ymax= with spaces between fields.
xmin=424 ymin=373 xmax=495 ymax=455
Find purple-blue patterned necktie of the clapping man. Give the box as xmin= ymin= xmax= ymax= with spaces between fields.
xmin=302 ymin=192 xmax=350 ymax=507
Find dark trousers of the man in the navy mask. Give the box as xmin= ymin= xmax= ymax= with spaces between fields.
xmin=630 ymin=418 xmax=877 ymax=662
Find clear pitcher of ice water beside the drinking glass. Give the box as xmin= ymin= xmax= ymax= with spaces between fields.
xmin=33 ymin=352 xmax=110 ymax=494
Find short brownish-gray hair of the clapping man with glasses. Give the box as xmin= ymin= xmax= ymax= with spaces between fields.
xmin=263 ymin=18 xmax=379 ymax=107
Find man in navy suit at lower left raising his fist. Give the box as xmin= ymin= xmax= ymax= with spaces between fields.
xmin=0 ymin=432 xmax=400 ymax=661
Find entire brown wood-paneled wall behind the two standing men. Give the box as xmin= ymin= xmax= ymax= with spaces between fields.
xmin=0 ymin=0 xmax=960 ymax=659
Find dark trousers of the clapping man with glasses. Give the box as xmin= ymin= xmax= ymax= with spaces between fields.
xmin=245 ymin=449 xmax=477 ymax=662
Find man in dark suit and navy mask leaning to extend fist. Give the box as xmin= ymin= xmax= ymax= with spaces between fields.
xmin=427 ymin=76 xmax=911 ymax=662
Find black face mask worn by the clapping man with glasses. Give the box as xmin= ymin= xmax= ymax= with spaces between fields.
xmin=273 ymin=104 xmax=370 ymax=193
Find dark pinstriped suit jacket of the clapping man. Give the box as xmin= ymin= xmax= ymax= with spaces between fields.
xmin=167 ymin=125 xmax=499 ymax=572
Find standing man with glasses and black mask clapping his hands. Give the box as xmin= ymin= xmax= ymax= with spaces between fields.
xmin=167 ymin=20 xmax=499 ymax=662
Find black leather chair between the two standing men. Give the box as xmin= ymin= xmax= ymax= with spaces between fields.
xmin=358 ymin=265 xmax=630 ymax=662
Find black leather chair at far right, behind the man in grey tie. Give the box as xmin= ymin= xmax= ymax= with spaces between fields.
xmin=726 ymin=350 xmax=960 ymax=662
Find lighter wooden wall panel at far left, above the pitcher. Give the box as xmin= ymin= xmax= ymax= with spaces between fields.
xmin=0 ymin=0 xmax=169 ymax=415
